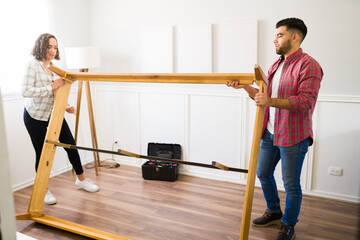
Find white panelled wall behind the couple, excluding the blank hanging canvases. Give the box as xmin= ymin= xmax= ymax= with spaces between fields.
xmin=3 ymin=0 xmax=360 ymax=202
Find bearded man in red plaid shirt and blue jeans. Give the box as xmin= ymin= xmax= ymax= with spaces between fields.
xmin=227 ymin=18 xmax=323 ymax=240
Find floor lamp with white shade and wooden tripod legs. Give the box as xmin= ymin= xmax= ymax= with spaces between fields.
xmin=65 ymin=47 xmax=100 ymax=176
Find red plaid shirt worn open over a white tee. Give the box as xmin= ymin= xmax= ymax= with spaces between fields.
xmin=263 ymin=48 xmax=323 ymax=147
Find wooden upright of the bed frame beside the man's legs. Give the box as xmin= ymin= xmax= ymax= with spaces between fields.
xmin=240 ymin=83 xmax=265 ymax=240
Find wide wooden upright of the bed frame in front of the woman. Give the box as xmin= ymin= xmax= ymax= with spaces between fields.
xmin=28 ymin=82 xmax=71 ymax=216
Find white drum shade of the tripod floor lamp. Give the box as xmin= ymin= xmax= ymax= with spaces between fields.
xmin=65 ymin=47 xmax=100 ymax=69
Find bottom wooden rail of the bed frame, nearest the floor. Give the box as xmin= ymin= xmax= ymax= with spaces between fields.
xmin=31 ymin=216 xmax=129 ymax=240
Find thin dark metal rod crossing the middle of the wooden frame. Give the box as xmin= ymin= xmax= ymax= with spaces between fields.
xmin=45 ymin=139 xmax=248 ymax=173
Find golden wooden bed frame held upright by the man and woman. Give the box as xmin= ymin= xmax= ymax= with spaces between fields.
xmin=16 ymin=65 xmax=267 ymax=240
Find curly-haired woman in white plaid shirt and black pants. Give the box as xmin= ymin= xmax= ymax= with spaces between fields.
xmin=22 ymin=33 xmax=99 ymax=204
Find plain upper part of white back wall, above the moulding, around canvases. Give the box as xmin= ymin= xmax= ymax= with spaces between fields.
xmin=89 ymin=0 xmax=360 ymax=95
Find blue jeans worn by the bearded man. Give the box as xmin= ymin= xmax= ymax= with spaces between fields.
xmin=256 ymin=130 xmax=309 ymax=225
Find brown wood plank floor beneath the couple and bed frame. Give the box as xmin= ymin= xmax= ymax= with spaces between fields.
xmin=14 ymin=165 xmax=360 ymax=240
